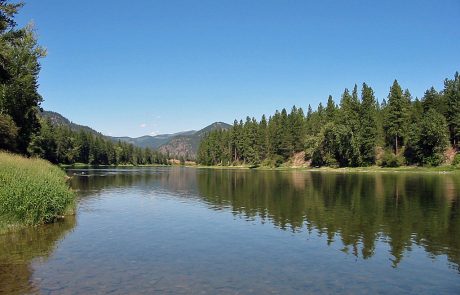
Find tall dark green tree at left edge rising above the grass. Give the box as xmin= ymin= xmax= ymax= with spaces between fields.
xmin=0 ymin=1 xmax=46 ymax=153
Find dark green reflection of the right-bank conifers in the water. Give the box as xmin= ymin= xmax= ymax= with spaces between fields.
xmin=197 ymin=170 xmax=460 ymax=268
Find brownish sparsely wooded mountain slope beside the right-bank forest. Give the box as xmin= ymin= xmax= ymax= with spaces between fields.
xmin=158 ymin=122 xmax=232 ymax=159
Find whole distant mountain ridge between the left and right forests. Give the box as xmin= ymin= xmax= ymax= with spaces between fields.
xmin=41 ymin=111 xmax=232 ymax=159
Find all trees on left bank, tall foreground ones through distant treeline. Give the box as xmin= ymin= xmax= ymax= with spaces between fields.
xmin=0 ymin=0 xmax=168 ymax=165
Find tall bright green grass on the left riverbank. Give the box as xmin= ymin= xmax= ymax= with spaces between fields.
xmin=0 ymin=151 xmax=75 ymax=232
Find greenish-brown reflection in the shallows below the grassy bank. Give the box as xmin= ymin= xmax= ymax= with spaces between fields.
xmin=0 ymin=216 xmax=75 ymax=294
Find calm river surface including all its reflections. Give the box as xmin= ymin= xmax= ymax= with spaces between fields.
xmin=0 ymin=168 xmax=460 ymax=294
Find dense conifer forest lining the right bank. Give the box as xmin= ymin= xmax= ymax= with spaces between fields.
xmin=198 ymin=72 xmax=460 ymax=167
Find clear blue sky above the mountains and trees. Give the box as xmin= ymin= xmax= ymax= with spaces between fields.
xmin=18 ymin=0 xmax=460 ymax=136
